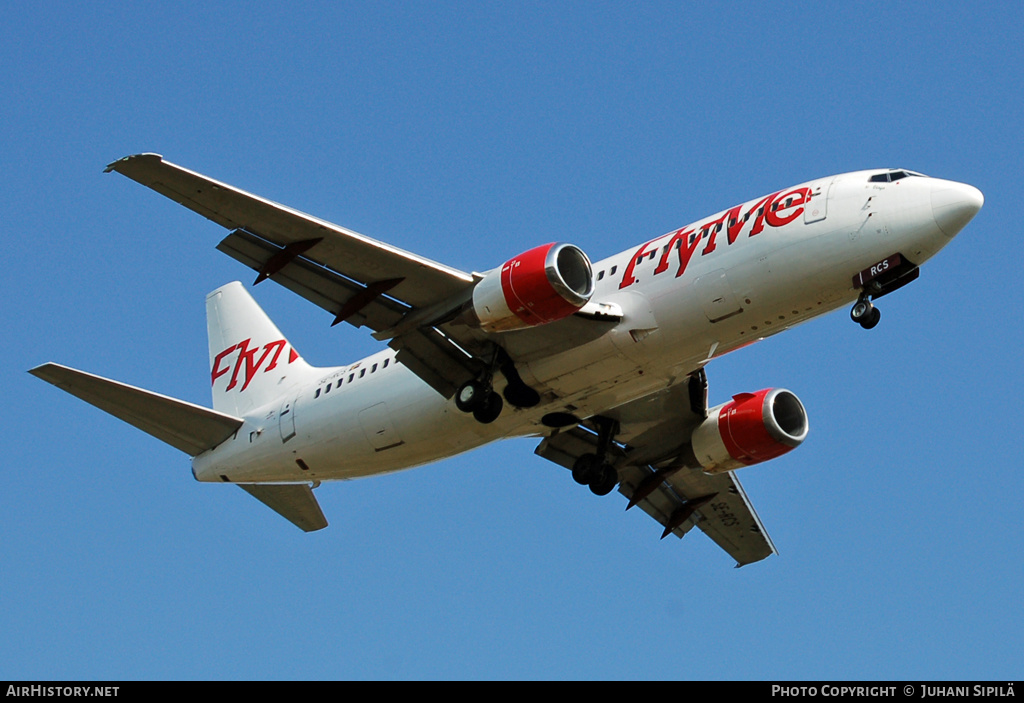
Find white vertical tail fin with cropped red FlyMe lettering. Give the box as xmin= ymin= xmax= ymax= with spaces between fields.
xmin=206 ymin=281 xmax=317 ymax=416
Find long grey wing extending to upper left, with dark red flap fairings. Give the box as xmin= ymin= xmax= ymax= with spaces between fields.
xmin=106 ymin=153 xmax=478 ymax=397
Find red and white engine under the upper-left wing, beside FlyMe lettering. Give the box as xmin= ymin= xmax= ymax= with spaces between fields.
xmin=473 ymin=244 xmax=594 ymax=332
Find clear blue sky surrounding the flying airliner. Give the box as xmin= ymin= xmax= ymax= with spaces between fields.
xmin=0 ymin=2 xmax=1024 ymax=679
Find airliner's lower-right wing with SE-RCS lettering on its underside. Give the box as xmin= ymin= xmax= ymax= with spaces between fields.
xmin=536 ymin=381 xmax=775 ymax=567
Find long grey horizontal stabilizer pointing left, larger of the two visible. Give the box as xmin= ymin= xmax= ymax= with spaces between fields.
xmin=29 ymin=363 xmax=241 ymax=456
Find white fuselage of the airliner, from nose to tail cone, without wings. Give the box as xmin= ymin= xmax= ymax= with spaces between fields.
xmin=193 ymin=172 xmax=971 ymax=482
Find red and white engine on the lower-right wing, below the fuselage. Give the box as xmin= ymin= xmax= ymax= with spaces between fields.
xmin=692 ymin=388 xmax=808 ymax=474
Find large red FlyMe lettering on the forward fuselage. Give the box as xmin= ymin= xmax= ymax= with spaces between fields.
xmin=618 ymin=187 xmax=811 ymax=289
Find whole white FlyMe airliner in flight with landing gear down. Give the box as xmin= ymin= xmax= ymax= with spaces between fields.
xmin=31 ymin=158 xmax=984 ymax=566
